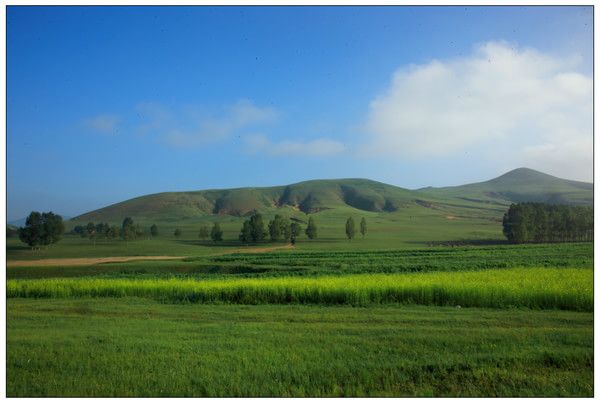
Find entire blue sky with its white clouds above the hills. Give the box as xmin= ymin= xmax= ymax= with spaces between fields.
xmin=7 ymin=7 xmax=593 ymax=221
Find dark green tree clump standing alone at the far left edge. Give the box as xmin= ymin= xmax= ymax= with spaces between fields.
xmin=19 ymin=211 xmax=65 ymax=249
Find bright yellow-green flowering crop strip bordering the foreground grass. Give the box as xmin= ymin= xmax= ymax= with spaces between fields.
xmin=7 ymin=268 xmax=593 ymax=311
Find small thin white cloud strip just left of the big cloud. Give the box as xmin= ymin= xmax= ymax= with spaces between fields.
xmin=246 ymin=134 xmax=345 ymax=157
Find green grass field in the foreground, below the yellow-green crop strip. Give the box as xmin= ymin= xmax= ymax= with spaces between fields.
xmin=7 ymin=298 xmax=594 ymax=396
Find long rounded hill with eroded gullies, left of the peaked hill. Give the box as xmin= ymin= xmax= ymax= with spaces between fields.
xmin=73 ymin=179 xmax=414 ymax=221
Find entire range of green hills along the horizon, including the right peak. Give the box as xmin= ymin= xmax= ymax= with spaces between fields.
xmin=73 ymin=168 xmax=593 ymax=221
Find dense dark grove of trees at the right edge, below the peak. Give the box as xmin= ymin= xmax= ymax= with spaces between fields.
xmin=502 ymin=203 xmax=594 ymax=243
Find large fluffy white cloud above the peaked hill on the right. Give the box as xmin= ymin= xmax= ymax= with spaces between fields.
xmin=365 ymin=42 xmax=593 ymax=179
